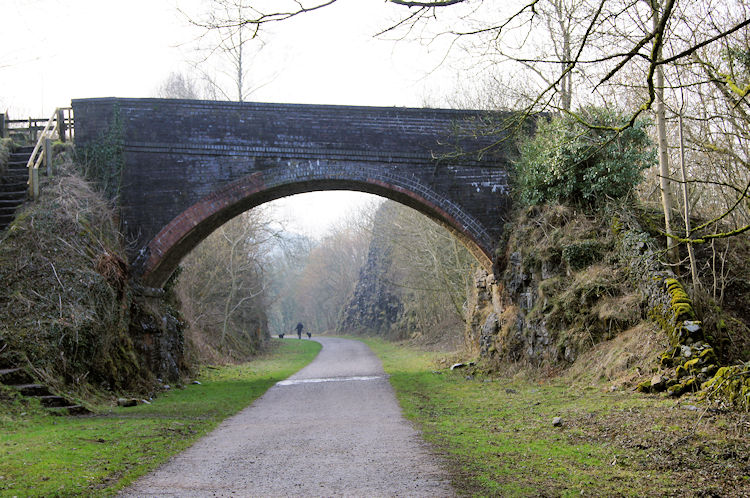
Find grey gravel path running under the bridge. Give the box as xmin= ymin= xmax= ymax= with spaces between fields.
xmin=122 ymin=338 xmax=454 ymax=497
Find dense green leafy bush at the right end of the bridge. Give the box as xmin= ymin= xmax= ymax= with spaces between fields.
xmin=515 ymin=108 xmax=656 ymax=206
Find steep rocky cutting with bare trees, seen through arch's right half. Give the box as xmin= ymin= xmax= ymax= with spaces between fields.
xmin=338 ymin=201 xmax=477 ymax=342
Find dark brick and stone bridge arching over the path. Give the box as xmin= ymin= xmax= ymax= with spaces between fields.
xmin=73 ymin=98 xmax=511 ymax=287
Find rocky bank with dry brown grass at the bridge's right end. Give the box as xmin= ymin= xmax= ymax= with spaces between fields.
xmin=484 ymin=205 xmax=645 ymax=368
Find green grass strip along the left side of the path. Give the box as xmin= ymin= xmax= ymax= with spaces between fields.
xmin=0 ymin=340 xmax=320 ymax=497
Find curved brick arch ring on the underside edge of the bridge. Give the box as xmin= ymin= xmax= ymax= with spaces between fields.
xmin=133 ymin=161 xmax=500 ymax=287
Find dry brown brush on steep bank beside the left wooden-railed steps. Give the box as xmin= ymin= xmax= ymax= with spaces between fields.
xmin=0 ymin=161 xmax=152 ymax=391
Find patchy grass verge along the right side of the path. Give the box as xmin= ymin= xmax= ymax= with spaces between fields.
xmin=365 ymin=339 xmax=750 ymax=496
